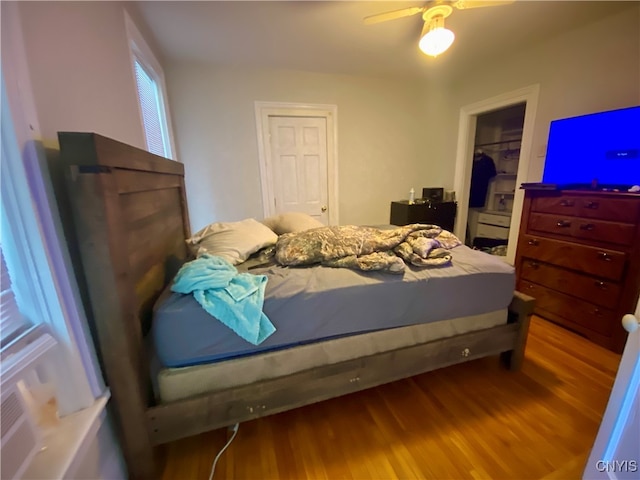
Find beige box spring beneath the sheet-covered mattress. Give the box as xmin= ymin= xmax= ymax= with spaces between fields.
xmin=152 ymin=309 xmax=508 ymax=403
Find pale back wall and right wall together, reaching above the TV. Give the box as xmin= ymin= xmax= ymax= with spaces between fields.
xmin=165 ymin=7 xmax=640 ymax=229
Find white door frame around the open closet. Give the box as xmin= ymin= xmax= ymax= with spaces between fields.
xmin=453 ymin=84 xmax=540 ymax=265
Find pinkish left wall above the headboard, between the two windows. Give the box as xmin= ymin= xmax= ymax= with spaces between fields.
xmin=20 ymin=2 xmax=152 ymax=148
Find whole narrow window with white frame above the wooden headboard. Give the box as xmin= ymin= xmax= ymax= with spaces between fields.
xmin=125 ymin=12 xmax=173 ymax=158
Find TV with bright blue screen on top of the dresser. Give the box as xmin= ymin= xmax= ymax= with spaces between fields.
xmin=542 ymin=106 xmax=640 ymax=189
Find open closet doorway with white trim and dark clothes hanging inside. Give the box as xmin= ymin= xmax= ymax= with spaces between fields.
xmin=454 ymin=85 xmax=539 ymax=264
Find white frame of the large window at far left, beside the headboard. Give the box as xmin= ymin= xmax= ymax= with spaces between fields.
xmin=0 ymin=3 xmax=105 ymax=416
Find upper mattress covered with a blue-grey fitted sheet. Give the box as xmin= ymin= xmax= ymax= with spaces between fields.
xmin=152 ymin=245 xmax=515 ymax=368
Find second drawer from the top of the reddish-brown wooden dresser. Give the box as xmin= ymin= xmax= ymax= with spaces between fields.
xmin=529 ymin=213 xmax=636 ymax=245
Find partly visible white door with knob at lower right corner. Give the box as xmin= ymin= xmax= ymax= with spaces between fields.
xmin=583 ymin=302 xmax=640 ymax=480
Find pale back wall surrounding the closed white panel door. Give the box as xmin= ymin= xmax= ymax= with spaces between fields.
xmin=165 ymin=63 xmax=430 ymax=231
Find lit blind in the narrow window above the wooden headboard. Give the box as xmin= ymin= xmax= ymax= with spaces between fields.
xmin=134 ymin=60 xmax=168 ymax=157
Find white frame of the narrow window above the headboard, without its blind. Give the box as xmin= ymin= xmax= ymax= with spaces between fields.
xmin=124 ymin=11 xmax=176 ymax=160
